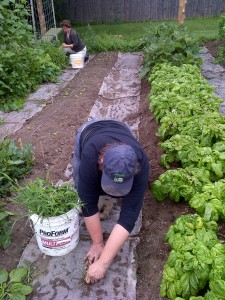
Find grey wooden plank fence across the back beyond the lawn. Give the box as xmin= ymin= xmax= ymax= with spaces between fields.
xmin=56 ymin=0 xmax=225 ymax=24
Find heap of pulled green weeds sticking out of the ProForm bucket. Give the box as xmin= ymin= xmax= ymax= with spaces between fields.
xmin=12 ymin=178 xmax=80 ymax=218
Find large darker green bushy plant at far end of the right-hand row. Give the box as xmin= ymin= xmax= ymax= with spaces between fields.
xmin=141 ymin=23 xmax=202 ymax=77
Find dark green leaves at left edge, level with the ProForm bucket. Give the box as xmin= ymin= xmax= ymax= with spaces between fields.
xmin=0 ymin=210 xmax=13 ymax=249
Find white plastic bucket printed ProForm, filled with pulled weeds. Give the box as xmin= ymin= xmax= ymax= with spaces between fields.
xmin=30 ymin=209 xmax=79 ymax=256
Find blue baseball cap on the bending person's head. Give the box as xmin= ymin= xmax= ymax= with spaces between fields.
xmin=101 ymin=144 xmax=137 ymax=197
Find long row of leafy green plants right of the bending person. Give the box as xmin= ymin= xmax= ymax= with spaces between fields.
xmin=143 ymin=22 xmax=225 ymax=300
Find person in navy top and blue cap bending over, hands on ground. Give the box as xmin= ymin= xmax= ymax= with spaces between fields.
xmin=73 ymin=120 xmax=149 ymax=283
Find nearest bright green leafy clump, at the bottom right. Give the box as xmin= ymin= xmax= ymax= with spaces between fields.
xmin=160 ymin=214 xmax=221 ymax=300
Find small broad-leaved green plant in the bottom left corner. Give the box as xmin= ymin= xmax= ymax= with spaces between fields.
xmin=0 ymin=267 xmax=33 ymax=300
